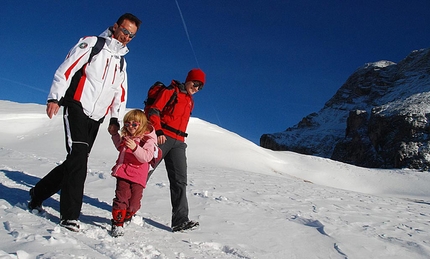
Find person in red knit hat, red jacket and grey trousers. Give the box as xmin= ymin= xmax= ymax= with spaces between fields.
xmin=147 ymin=69 xmax=206 ymax=232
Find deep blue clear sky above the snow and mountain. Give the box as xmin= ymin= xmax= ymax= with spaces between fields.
xmin=0 ymin=0 xmax=430 ymax=144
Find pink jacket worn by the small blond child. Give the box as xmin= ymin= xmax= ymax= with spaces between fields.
xmin=112 ymin=129 xmax=158 ymax=188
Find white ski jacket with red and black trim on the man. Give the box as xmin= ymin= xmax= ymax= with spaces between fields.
xmin=48 ymin=29 xmax=128 ymax=121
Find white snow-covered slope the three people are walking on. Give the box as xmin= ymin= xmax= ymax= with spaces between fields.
xmin=0 ymin=101 xmax=430 ymax=259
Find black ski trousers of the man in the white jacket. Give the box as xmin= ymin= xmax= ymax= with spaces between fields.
xmin=34 ymin=104 xmax=100 ymax=219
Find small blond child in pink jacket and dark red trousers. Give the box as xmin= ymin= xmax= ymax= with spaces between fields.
xmin=110 ymin=109 xmax=158 ymax=237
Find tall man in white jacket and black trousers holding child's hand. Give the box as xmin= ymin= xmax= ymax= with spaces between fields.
xmin=28 ymin=13 xmax=141 ymax=234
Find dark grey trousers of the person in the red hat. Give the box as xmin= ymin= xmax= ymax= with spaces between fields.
xmin=148 ymin=136 xmax=189 ymax=227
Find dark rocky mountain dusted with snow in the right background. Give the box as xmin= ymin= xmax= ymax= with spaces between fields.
xmin=260 ymin=48 xmax=430 ymax=170
